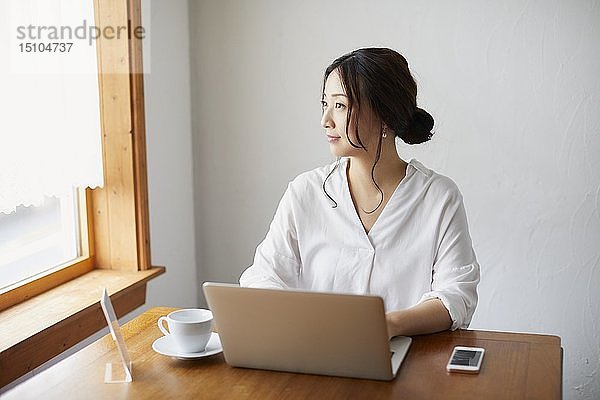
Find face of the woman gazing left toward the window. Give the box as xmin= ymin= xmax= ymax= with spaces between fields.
xmin=321 ymin=71 xmax=380 ymax=157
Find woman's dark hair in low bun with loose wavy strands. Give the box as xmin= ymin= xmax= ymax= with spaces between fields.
xmin=321 ymin=47 xmax=434 ymax=213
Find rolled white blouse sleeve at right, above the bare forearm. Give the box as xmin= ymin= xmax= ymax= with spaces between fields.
xmin=419 ymin=189 xmax=479 ymax=330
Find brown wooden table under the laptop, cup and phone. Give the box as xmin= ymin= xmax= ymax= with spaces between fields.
xmin=2 ymin=307 xmax=562 ymax=400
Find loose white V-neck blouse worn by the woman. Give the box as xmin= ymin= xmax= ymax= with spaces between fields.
xmin=240 ymin=159 xmax=479 ymax=329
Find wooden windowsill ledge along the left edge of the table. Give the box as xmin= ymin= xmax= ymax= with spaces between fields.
xmin=0 ymin=267 xmax=165 ymax=387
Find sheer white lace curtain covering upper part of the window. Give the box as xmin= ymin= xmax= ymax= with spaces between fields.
xmin=0 ymin=0 xmax=103 ymax=213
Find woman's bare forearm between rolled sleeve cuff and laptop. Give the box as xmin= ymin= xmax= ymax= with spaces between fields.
xmin=386 ymin=299 xmax=452 ymax=338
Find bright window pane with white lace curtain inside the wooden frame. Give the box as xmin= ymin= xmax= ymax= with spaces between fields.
xmin=0 ymin=0 xmax=103 ymax=290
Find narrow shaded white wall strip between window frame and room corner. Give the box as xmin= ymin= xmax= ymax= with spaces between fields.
xmin=139 ymin=0 xmax=199 ymax=312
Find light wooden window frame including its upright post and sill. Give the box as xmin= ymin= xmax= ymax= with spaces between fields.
xmin=0 ymin=0 xmax=165 ymax=388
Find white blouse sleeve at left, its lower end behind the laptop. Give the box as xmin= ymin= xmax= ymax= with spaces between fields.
xmin=240 ymin=185 xmax=301 ymax=289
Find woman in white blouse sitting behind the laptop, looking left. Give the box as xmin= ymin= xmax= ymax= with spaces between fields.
xmin=240 ymin=48 xmax=479 ymax=336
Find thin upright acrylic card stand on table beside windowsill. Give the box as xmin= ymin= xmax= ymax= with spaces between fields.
xmin=100 ymin=288 xmax=133 ymax=383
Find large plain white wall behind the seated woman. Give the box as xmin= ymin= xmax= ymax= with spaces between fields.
xmin=190 ymin=0 xmax=600 ymax=399
